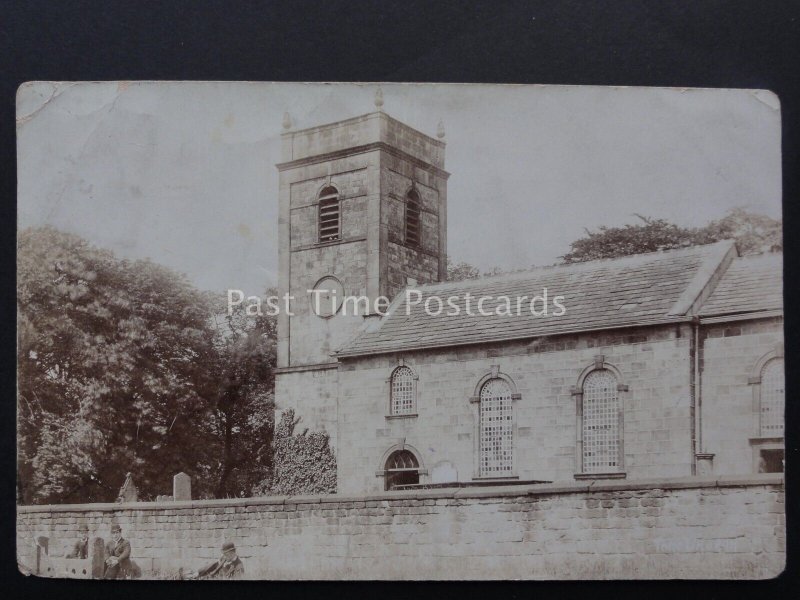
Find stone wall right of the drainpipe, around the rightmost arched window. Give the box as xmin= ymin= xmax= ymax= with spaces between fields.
xmin=701 ymin=319 xmax=783 ymax=474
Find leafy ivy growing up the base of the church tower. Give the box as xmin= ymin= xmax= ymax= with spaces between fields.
xmin=269 ymin=409 xmax=336 ymax=496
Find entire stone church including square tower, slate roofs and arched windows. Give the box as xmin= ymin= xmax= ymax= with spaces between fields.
xmin=276 ymin=103 xmax=784 ymax=494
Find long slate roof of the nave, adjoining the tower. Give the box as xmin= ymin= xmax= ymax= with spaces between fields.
xmin=337 ymin=241 xmax=735 ymax=357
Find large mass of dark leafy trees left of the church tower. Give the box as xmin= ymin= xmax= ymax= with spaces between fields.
xmin=17 ymin=228 xmax=274 ymax=503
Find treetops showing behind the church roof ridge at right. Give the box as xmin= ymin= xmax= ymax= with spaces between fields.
xmin=561 ymin=208 xmax=782 ymax=263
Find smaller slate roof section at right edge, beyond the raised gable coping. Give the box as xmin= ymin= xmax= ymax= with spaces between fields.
xmin=700 ymin=253 xmax=783 ymax=316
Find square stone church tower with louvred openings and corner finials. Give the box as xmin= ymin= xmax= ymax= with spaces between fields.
xmin=275 ymin=92 xmax=449 ymax=445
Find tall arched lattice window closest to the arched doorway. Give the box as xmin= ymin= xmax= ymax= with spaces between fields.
xmin=478 ymin=377 xmax=514 ymax=477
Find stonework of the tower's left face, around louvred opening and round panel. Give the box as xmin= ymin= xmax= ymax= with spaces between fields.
xmin=275 ymin=147 xmax=380 ymax=434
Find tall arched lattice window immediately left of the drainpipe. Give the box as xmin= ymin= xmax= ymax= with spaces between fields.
xmin=581 ymin=369 xmax=622 ymax=473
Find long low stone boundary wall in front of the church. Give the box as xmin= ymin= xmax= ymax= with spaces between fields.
xmin=17 ymin=474 xmax=785 ymax=579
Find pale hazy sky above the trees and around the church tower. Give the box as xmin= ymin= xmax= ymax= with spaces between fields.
xmin=17 ymin=82 xmax=781 ymax=294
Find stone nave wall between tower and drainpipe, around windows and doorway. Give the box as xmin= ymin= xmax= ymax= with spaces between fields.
xmin=337 ymin=326 xmax=693 ymax=493
